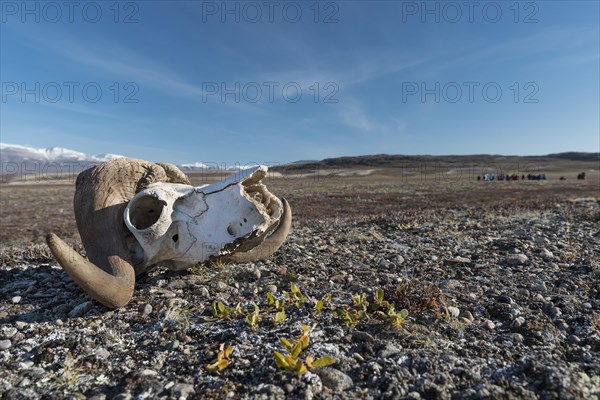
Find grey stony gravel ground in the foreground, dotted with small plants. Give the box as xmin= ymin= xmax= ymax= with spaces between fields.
xmin=0 ymin=200 xmax=600 ymax=399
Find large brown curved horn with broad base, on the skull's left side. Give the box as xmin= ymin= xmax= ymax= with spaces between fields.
xmin=46 ymin=158 xmax=187 ymax=308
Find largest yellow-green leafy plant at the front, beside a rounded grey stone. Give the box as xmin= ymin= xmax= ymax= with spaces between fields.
xmin=273 ymin=324 xmax=335 ymax=375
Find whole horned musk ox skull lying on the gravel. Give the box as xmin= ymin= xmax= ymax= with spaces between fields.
xmin=46 ymin=158 xmax=292 ymax=308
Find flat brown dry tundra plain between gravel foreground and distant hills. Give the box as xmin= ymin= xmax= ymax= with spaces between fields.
xmin=0 ymin=168 xmax=600 ymax=246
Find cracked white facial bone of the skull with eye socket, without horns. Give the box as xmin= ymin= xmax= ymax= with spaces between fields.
xmin=124 ymin=166 xmax=283 ymax=270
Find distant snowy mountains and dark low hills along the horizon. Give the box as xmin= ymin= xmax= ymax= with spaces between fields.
xmin=0 ymin=143 xmax=600 ymax=181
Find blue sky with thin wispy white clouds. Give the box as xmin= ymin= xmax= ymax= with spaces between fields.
xmin=0 ymin=1 xmax=600 ymax=164
